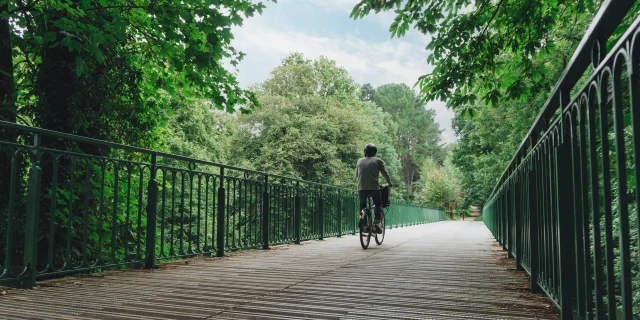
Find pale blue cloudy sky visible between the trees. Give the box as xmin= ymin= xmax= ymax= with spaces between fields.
xmin=233 ymin=0 xmax=456 ymax=143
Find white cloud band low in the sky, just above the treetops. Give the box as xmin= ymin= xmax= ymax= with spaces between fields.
xmin=234 ymin=21 xmax=431 ymax=86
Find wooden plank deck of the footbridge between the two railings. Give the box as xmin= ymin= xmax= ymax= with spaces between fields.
xmin=0 ymin=221 xmax=557 ymax=319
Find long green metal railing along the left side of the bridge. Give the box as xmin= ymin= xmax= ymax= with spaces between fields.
xmin=0 ymin=122 xmax=444 ymax=287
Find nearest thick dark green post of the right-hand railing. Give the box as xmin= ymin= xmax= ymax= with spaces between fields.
xmin=555 ymin=142 xmax=576 ymax=320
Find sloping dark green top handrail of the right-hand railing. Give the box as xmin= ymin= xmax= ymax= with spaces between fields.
xmin=488 ymin=0 xmax=635 ymax=199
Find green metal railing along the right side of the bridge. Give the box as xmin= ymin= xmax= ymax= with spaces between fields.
xmin=483 ymin=0 xmax=640 ymax=319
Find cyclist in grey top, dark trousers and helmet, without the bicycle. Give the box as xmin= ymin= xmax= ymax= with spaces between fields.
xmin=356 ymin=143 xmax=393 ymax=233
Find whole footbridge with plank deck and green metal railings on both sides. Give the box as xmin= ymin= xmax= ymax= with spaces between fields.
xmin=0 ymin=0 xmax=640 ymax=320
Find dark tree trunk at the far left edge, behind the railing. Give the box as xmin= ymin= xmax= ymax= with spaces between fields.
xmin=0 ymin=0 xmax=17 ymax=211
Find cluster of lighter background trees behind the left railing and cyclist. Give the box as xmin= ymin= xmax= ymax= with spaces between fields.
xmin=178 ymin=53 xmax=444 ymax=199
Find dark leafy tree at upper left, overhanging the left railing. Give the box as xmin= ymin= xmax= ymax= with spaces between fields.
xmin=0 ymin=0 xmax=264 ymax=142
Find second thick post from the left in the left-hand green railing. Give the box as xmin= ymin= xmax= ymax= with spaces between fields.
xmin=145 ymin=153 xmax=158 ymax=269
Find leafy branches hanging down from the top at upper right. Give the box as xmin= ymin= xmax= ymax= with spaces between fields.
xmin=351 ymin=0 xmax=600 ymax=110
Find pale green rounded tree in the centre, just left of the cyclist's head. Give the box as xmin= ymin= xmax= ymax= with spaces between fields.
xmin=234 ymin=53 xmax=400 ymax=187
